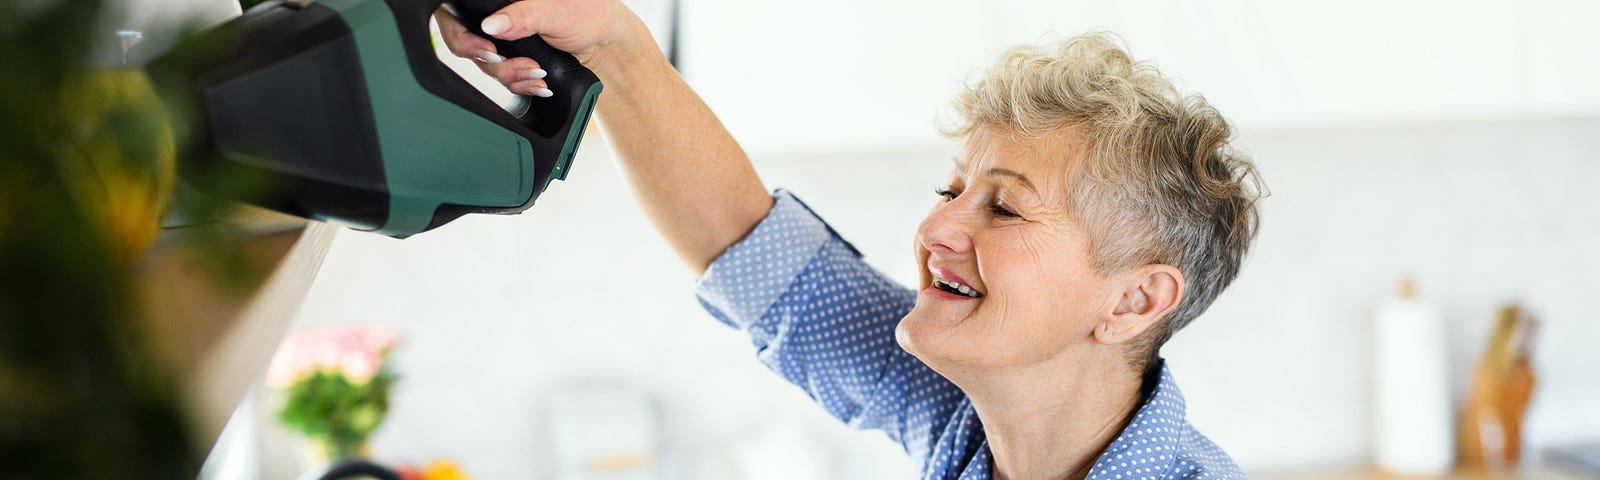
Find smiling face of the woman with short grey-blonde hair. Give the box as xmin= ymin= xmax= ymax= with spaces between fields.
xmin=896 ymin=128 xmax=1117 ymax=376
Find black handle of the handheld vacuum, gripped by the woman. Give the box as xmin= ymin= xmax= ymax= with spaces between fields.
xmin=443 ymin=0 xmax=600 ymax=138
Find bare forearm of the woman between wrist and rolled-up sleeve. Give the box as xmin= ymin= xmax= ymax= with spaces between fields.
xmin=590 ymin=24 xmax=773 ymax=277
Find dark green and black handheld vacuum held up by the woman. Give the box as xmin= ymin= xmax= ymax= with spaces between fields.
xmin=147 ymin=0 xmax=600 ymax=238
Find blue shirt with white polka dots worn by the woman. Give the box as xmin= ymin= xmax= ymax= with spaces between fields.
xmin=696 ymin=190 xmax=1245 ymax=480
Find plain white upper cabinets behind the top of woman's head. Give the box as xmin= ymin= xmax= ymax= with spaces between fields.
xmin=682 ymin=0 xmax=1600 ymax=154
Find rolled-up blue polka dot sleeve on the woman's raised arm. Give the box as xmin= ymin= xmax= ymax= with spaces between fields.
xmin=696 ymin=190 xmax=963 ymax=456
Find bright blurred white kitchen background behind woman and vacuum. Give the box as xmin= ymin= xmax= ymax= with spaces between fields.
xmin=103 ymin=0 xmax=1600 ymax=478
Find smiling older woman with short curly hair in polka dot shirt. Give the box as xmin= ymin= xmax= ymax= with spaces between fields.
xmin=440 ymin=0 xmax=1256 ymax=478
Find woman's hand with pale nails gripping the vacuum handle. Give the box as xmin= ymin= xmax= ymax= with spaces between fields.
xmin=434 ymin=0 xmax=654 ymax=96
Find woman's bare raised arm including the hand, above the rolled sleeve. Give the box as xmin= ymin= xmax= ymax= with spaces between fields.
xmin=435 ymin=0 xmax=773 ymax=277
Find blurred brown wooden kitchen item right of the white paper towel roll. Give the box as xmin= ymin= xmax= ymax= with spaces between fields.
xmin=1456 ymin=306 xmax=1534 ymax=470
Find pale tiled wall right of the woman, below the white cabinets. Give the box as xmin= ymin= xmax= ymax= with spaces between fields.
xmin=1166 ymin=117 xmax=1600 ymax=469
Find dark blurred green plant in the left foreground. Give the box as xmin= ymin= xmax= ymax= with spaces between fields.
xmin=0 ymin=0 xmax=258 ymax=478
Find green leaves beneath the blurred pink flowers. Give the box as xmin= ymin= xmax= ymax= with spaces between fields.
xmin=278 ymin=368 xmax=395 ymax=459
